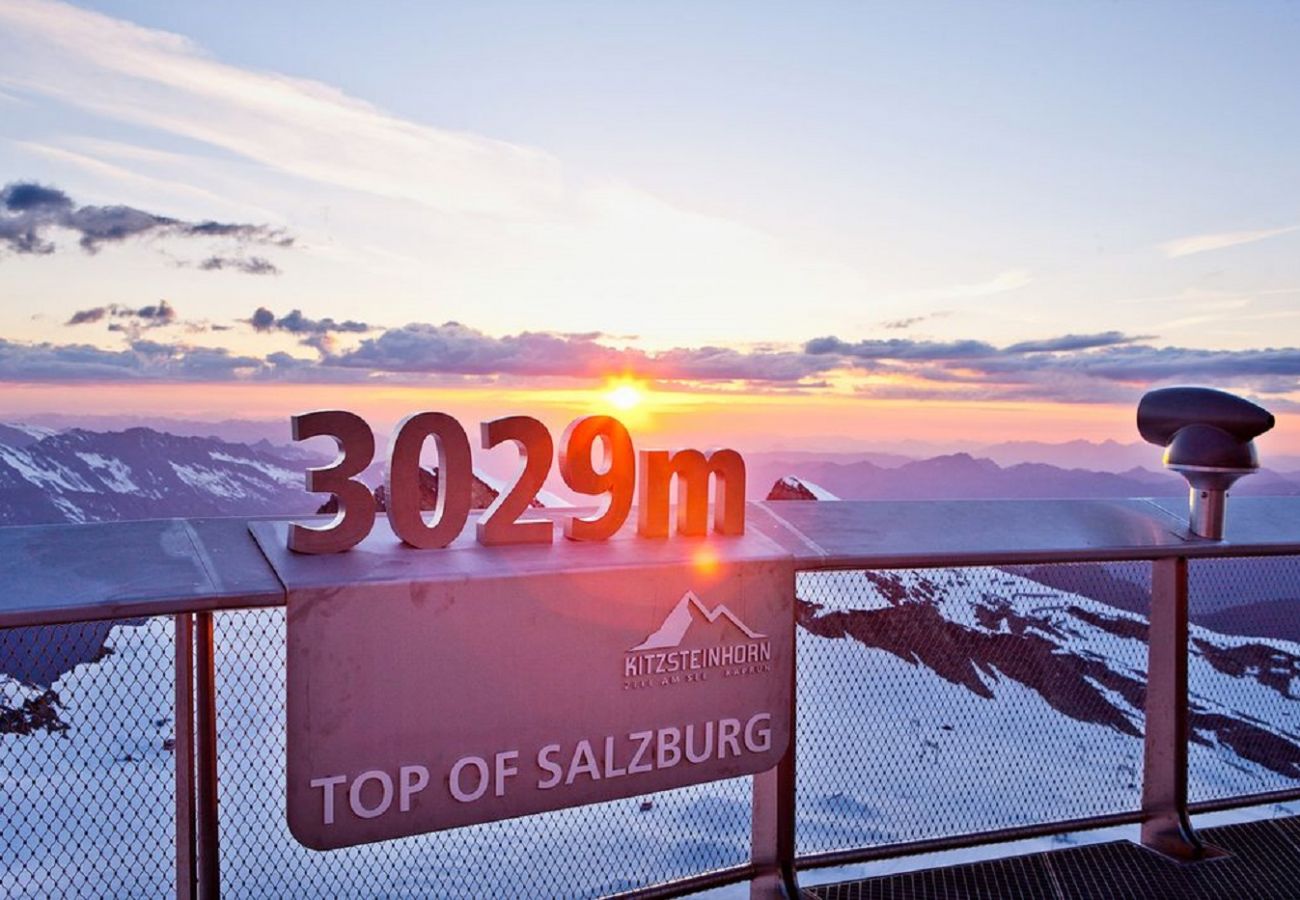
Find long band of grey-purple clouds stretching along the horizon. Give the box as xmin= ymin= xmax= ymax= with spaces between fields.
xmin=0 ymin=310 xmax=1300 ymax=402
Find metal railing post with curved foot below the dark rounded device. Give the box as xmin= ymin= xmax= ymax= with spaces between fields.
xmin=1141 ymin=557 xmax=1218 ymax=860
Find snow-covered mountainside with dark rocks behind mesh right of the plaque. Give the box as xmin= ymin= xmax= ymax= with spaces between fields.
xmin=798 ymin=567 xmax=1300 ymax=840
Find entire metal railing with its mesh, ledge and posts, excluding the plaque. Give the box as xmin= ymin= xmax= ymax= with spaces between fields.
xmin=0 ymin=499 xmax=1300 ymax=897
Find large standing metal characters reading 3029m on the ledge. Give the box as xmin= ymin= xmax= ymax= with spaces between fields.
xmin=289 ymin=410 xmax=745 ymax=554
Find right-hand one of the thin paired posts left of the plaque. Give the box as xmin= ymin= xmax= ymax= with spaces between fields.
xmin=195 ymin=613 xmax=221 ymax=900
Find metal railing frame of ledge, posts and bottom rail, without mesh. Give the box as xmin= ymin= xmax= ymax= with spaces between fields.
xmin=0 ymin=498 xmax=1300 ymax=900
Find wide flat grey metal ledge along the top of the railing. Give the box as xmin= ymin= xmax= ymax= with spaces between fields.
xmin=0 ymin=497 xmax=1300 ymax=627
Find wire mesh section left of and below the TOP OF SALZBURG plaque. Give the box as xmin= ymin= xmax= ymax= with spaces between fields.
xmin=215 ymin=610 xmax=751 ymax=897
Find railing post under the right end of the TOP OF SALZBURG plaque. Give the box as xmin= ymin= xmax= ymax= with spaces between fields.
xmin=749 ymin=619 xmax=802 ymax=900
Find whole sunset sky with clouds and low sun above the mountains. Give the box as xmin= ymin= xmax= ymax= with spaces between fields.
xmin=0 ymin=0 xmax=1300 ymax=453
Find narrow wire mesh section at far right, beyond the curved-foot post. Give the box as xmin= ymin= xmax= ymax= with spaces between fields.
xmin=1187 ymin=557 xmax=1300 ymax=802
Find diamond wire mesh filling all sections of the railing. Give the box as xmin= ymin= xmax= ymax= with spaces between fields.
xmin=0 ymin=558 xmax=1300 ymax=896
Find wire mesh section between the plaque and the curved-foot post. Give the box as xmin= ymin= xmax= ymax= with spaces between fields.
xmin=797 ymin=563 xmax=1149 ymax=853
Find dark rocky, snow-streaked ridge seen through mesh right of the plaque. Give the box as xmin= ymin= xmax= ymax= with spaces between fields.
xmin=801 ymin=568 xmax=1300 ymax=780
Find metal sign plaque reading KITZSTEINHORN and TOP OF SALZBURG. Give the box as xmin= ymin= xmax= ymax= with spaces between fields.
xmin=245 ymin=523 xmax=794 ymax=849
